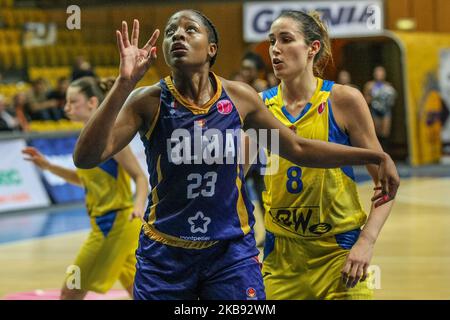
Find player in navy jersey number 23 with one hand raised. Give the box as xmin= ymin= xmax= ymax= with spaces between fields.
xmin=74 ymin=10 xmax=399 ymax=300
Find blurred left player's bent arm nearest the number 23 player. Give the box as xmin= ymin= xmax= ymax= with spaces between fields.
xmin=114 ymin=146 xmax=148 ymax=220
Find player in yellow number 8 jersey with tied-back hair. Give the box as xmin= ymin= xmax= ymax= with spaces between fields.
xmin=261 ymin=11 xmax=392 ymax=299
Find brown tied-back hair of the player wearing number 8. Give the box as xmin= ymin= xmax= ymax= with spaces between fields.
xmin=276 ymin=10 xmax=333 ymax=76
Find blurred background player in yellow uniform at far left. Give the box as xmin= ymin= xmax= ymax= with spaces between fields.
xmin=23 ymin=77 xmax=148 ymax=299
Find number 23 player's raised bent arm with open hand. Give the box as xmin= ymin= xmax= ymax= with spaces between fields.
xmin=74 ymin=20 xmax=159 ymax=168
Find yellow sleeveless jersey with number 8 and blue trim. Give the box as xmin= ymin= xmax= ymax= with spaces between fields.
xmin=261 ymin=78 xmax=367 ymax=238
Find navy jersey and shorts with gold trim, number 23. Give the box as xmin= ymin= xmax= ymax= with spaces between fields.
xmin=134 ymin=73 xmax=265 ymax=300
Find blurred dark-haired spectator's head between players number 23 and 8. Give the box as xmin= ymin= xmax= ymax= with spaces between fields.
xmin=240 ymin=52 xmax=267 ymax=92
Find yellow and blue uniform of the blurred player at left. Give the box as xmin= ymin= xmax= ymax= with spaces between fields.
xmin=66 ymin=158 xmax=142 ymax=293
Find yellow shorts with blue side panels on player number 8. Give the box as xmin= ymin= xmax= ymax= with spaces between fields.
xmin=262 ymin=230 xmax=373 ymax=300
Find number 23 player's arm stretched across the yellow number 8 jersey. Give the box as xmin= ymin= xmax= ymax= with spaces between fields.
xmin=227 ymin=82 xmax=400 ymax=204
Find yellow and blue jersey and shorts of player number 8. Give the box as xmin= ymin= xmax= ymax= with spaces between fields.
xmin=261 ymin=78 xmax=371 ymax=299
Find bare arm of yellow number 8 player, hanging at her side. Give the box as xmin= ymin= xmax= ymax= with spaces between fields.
xmin=332 ymin=85 xmax=394 ymax=287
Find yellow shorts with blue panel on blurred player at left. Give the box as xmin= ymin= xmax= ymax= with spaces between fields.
xmin=66 ymin=208 xmax=142 ymax=293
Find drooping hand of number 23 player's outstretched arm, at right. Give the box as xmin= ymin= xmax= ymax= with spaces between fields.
xmin=372 ymin=153 xmax=400 ymax=208
